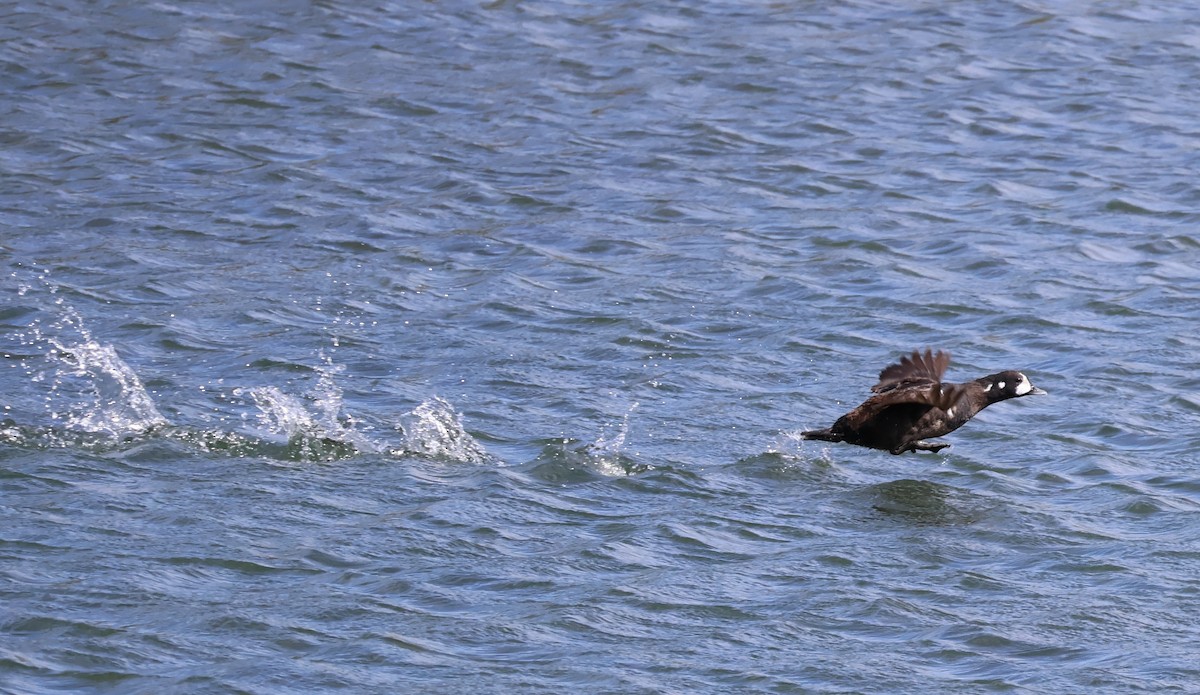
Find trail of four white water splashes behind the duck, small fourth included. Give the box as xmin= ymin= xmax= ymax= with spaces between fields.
xmin=0 ymin=271 xmax=696 ymax=472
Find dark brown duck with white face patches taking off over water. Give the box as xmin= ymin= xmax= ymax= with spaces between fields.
xmin=800 ymin=348 xmax=1046 ymax=455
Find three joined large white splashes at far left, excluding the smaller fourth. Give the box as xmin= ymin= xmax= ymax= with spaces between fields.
xmin=0 ymin=276 xmax=498 ymax=463
